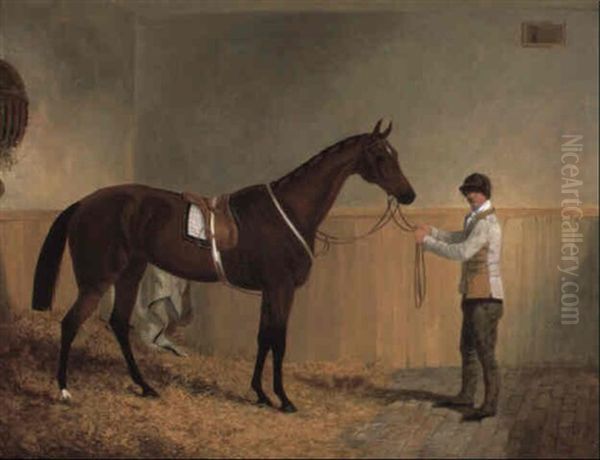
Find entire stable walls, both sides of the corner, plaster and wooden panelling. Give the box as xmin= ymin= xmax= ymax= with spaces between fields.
xmin=0 ymin=0 xmax=598 ymax=367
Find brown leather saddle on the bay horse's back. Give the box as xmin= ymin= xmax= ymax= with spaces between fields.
xmin=181 ymin=192 xmax=238 ymax=250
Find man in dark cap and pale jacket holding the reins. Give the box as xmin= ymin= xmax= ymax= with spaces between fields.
xmin=415 ymin=173 xmax=504 ymax=420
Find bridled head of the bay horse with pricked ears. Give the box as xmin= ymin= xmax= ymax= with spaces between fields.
xmin=356 ymin=120 xmax=416 ymax=204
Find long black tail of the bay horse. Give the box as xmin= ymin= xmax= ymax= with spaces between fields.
xmin=31 ymin=202 xmax=79 ymax=311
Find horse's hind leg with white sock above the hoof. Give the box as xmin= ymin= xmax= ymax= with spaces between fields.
xmin=57 ymin=284 xmax=108 ymax=401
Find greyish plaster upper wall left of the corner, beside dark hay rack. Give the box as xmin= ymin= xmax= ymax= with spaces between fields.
xmin=0 ymin=0 xmax=135 ymax=209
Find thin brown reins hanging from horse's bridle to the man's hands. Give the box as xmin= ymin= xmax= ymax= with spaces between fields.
xmin=316 ymin=195 xmax=427 ymax=308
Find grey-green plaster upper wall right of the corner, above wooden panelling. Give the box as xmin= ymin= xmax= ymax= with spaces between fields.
xmin=135 ymin=3 xmax=598 ymax=207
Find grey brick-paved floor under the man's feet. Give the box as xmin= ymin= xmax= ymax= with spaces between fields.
xmin=344 ymin=367 xmax=600 ymax=458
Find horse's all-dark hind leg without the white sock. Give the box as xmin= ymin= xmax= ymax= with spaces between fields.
xmin=110 ymin=261 xmax=158 ymax=397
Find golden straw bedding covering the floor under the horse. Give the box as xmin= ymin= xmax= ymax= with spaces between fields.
xmin=0 ymin=312 xmax=391 ymax=457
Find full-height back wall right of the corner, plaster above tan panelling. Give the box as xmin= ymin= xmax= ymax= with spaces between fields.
xmin=135 ymin=2 xmax=598 ymax=367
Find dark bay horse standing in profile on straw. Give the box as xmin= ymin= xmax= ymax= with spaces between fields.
xmin=32 ymin=120 xmax=415 ymax=412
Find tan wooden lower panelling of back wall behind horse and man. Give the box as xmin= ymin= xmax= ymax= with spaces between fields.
xmin=186 ymin=209 xmax=599 ymax=368
